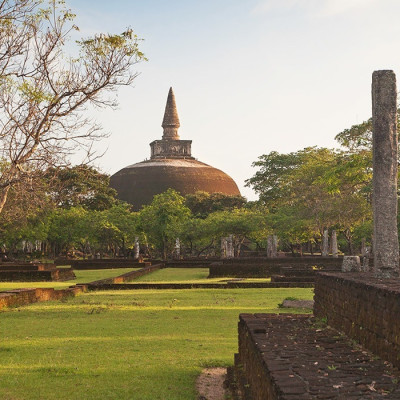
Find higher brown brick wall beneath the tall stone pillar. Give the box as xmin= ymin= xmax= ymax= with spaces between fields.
xmin=314 ymin=273 xmax=400 ymax=367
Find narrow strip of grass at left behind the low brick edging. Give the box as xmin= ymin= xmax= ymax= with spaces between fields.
xmin=0 ymin=268 xmax=139 ymax=291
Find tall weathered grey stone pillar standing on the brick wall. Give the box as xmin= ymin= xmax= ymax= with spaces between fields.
xmin=372 ymin=70 xmax=399 ymax=278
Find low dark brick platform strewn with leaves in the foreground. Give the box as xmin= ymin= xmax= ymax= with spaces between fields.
xmin=234 ymin=314 xmax=400 ymax=400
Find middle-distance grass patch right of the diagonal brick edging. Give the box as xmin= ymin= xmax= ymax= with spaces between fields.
xmin=133 ymin=268 xmax=271 ymax=283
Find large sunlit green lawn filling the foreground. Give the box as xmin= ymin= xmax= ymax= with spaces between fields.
xmin=0 ymin=289 xmax=313 ymax=400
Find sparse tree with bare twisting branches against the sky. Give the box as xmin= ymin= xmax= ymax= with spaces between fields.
xmin=0 ymin=0 xmax=145 ymax=213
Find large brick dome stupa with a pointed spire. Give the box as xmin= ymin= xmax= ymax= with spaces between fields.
xmin=110 ymin=88 xmax=240 ymax=210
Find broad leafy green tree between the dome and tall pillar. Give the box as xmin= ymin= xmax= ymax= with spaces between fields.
xmin=247 ymin=147 xmax=372 ymax=251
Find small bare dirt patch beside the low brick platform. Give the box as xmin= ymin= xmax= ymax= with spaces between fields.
xmin=196 ymin=368 xmax=226 ymax=400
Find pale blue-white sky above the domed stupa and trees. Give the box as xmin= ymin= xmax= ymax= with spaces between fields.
xmin=67 ymin=0 xmax=400 ymax=200
